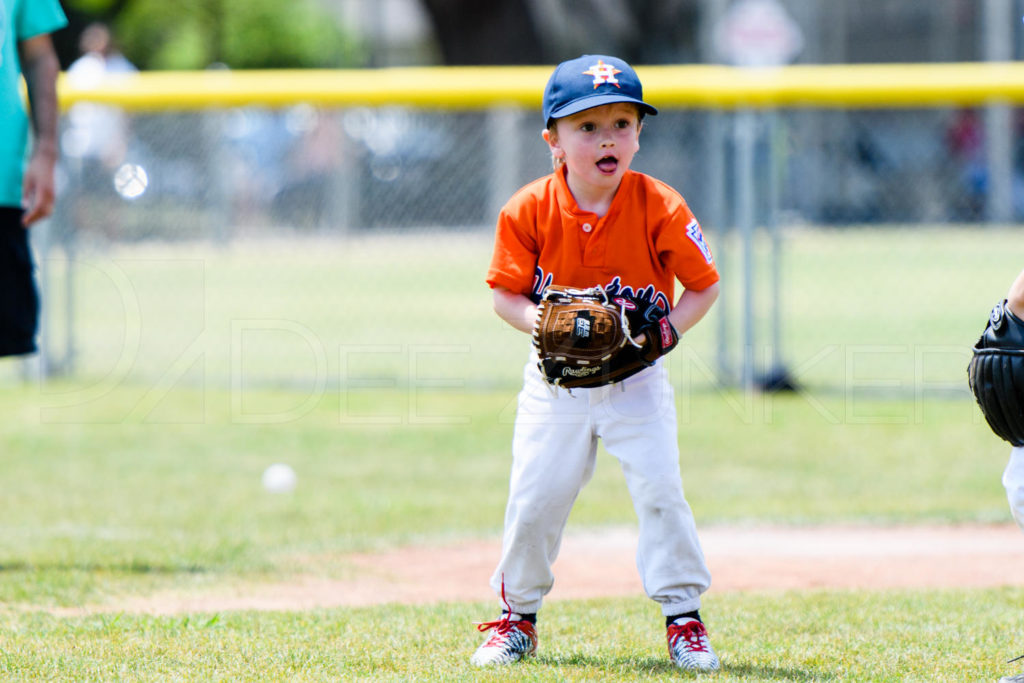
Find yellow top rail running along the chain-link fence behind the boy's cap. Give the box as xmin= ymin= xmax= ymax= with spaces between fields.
xmin=58 ymin=62 xmax=1024 ymax=110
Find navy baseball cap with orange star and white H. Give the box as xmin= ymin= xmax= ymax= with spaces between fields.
xmin=544 ymin=54 xmax=657 ymax=125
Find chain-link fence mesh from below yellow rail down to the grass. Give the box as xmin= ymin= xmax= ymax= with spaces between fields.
xmin=9 ymin=94 xmax=1024 ymax=413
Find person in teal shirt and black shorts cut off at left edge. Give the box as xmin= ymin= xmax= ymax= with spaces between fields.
xmin=0 ymin=0 xmax=68 ymax=355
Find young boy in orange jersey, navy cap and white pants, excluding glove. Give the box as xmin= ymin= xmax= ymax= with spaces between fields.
xmin=471 ymin=55 xmax=719 ymax=671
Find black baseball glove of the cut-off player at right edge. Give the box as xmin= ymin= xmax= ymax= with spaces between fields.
xmin=967 ymin=301 xmax=1024 ymax=445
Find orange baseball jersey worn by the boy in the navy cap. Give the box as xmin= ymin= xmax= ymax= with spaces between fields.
xmin=486 ymin=167 xmax=719 ymax=310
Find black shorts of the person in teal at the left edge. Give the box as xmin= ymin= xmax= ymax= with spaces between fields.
xmin=0 ymin=207 xmax=39 ymax=356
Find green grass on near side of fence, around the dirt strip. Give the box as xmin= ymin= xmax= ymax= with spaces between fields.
xmin=0 ymin=387 xmax=1024 ymax=681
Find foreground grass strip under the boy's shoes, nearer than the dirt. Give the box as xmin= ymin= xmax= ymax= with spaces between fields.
xmin=0 ymin=589 xmax=1024 ymax=682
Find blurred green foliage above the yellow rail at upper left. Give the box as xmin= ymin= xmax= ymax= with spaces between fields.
xmin=55 ymin=0 xmax=364 ymax=69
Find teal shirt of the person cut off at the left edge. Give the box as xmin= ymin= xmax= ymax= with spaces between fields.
xmin=0 ymin=0 xmax=68 ymax=207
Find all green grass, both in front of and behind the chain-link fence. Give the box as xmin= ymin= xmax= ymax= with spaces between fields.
xmin=0 ymin=230 xmax=1024 ymax=681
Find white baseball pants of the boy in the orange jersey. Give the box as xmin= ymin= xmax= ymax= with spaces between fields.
xmin=490 ymin=356 xmax=711 ymax=616
